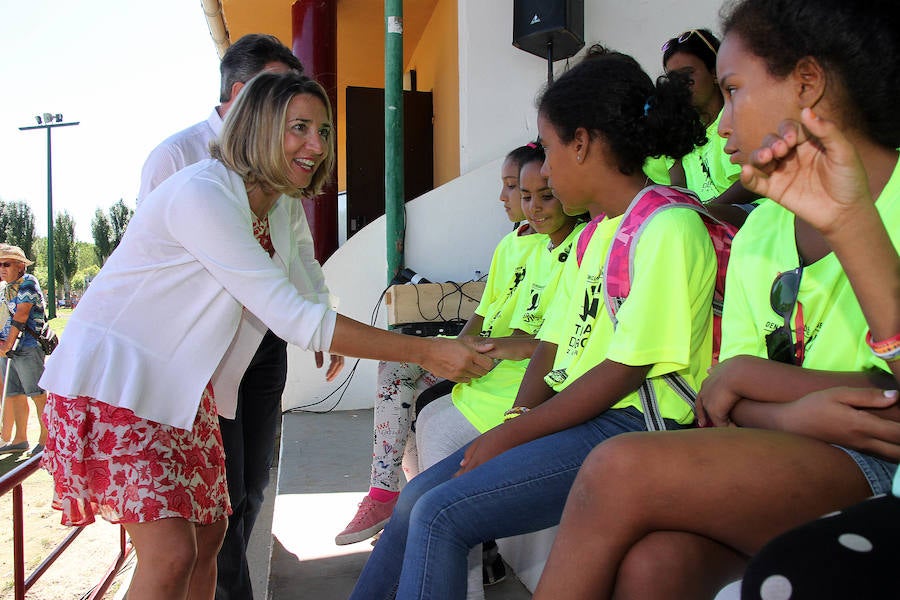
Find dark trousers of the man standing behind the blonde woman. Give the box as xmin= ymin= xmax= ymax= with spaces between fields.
xmin=214 ymin=331 xmax=287 ymax=600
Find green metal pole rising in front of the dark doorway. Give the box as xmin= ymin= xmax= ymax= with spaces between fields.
xmin=384 ymin=0 xmax=406 ymax=285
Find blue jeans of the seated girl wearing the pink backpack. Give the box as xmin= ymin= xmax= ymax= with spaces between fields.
xmin=351 ymin=408 xmax=681 ymax=600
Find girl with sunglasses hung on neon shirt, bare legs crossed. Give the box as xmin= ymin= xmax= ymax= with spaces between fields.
xmin=535 ymin=0 xmax=900 ymax=599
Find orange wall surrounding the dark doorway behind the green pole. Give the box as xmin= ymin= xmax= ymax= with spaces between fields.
xmin=216 ymin=0 xmax=459 ymax=190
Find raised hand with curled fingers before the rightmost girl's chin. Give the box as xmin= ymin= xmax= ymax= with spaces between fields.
xmin=741 ymin=108 xmax=872 ymax=236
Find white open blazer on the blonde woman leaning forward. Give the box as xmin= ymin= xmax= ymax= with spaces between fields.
xmin=41 ymin=159 xmax=336 ymax=429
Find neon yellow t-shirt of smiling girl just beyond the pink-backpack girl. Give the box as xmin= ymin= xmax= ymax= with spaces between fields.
xmin=452 ymin=223 xmax=584 ymax=433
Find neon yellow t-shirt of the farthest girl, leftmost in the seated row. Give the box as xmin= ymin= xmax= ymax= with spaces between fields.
xmin=475 ymin=230 xmax=550 ymax=337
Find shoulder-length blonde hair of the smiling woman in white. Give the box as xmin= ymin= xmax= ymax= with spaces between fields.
xmin=210 ymin=71 xmax=334 ymax=198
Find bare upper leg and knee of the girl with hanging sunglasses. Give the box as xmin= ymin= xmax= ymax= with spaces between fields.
xmin=535 ymin=428 xmax=871 ymax=598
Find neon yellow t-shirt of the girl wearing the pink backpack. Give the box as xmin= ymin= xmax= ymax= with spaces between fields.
xmin=539 ymin=209 xmax=716 ymax=423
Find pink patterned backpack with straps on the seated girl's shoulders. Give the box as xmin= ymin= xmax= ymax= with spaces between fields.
xmin=576 ymin=185 xmax=737 ymax=431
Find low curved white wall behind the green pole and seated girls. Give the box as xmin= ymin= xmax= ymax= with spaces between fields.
xmin=283 ymin=159 xmax=511 ymax=410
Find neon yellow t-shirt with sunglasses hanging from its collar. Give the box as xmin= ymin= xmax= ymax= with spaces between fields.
xmin=720 ymin=157 xmax=900 ymax=372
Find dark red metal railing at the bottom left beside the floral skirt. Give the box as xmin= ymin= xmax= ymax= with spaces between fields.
xmin=0 ymin=453 xmax=131 ymax=600
